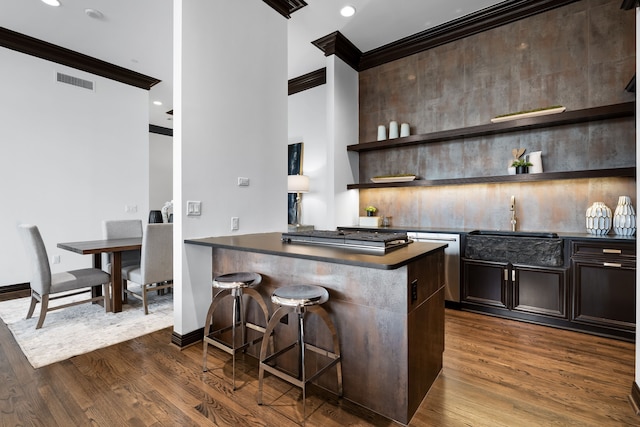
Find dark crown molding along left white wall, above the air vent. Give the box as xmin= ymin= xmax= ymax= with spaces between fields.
xmin=0 ymin=27 xmax=160 ymax=90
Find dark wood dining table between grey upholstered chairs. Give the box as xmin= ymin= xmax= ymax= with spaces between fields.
xmin=57 ymin=237 xmax=142 ymax=313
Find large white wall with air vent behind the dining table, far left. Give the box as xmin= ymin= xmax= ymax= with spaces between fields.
xmin=0 ymin=48 xmax=149 ymax=285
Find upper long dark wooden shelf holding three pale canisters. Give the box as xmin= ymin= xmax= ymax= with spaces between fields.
xmin=347 ymin=101 xmax=635 ymax=153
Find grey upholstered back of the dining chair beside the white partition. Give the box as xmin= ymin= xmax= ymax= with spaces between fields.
xmin=140 ymin=223 xmax=173 ymax=283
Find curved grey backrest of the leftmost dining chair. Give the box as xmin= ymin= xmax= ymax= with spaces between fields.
xmin=18 ymin=224 xmax=51 ymax=295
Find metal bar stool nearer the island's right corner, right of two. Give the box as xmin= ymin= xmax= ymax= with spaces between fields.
xmin=258 ymin=285 xmax=342 ymax=419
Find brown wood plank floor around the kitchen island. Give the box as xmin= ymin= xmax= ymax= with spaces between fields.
xmin=0 ymin=310 xmax=640 ymax=427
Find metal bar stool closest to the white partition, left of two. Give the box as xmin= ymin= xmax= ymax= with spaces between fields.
xmin=202 ymin=272 xmax=269 ymax=390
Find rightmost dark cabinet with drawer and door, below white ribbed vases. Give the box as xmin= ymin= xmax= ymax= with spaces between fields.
xmin=571 ymin=241 xmax=636 ymax=332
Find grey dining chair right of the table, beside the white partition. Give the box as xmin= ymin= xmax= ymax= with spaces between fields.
xmin=122 ymin=223 xmax=173 ymax=314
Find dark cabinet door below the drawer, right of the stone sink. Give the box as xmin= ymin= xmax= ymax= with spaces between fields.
xmin=571 ymin=260 xmax=636 ymax=331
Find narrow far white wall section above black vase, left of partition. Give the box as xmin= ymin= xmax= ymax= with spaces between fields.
xmin=149 ymin=133 xmax=173 ymax=210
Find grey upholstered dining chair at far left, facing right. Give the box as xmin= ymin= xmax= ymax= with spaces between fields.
xmin=18 ymin=224 xmax=111 ymax=329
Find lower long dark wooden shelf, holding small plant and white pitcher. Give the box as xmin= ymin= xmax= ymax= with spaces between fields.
xmin=347 ymin=167 xmax=636 ymax=190
